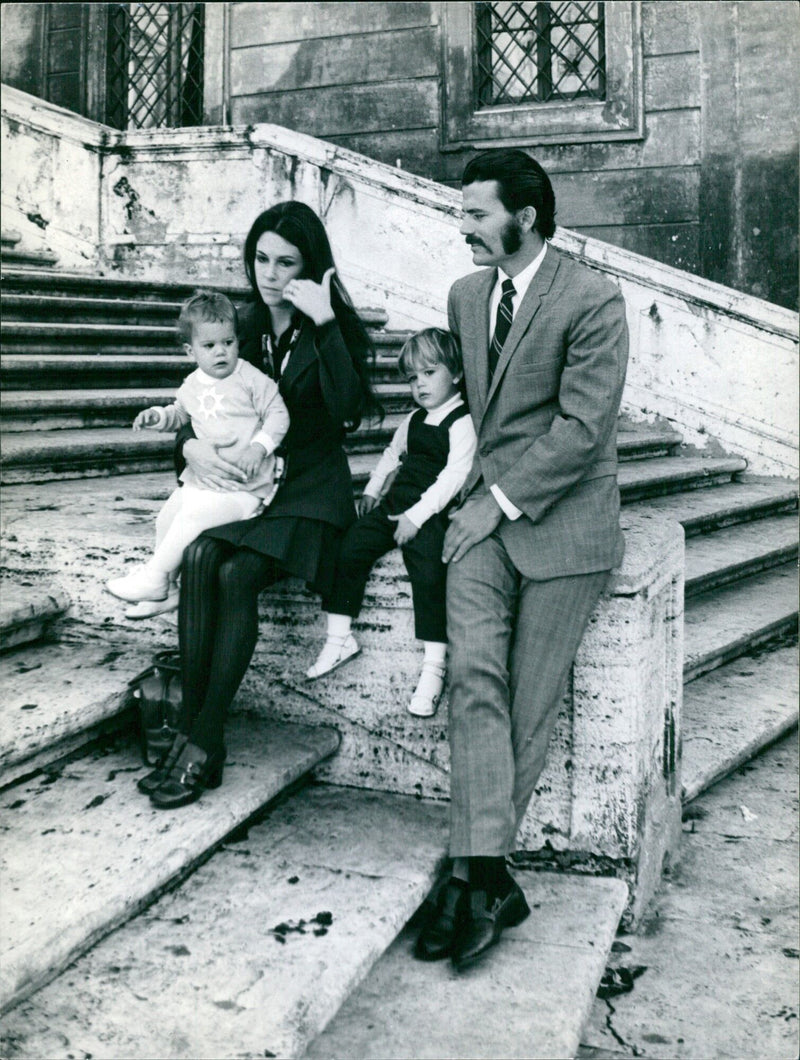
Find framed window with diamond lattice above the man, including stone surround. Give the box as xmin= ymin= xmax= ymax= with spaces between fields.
xmin=442 ymin=0 xmax=643 ymax=151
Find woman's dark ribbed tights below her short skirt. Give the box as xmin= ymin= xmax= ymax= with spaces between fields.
xmin=178 ymin=537 xmax=282 ymax=755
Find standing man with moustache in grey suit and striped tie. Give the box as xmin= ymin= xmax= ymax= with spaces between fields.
xmin=415 ymin=149 xmax=627 ymax=968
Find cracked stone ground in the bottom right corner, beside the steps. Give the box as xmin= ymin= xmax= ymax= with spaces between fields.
xmin=580 ymin=732 xmax=800 ymax=1060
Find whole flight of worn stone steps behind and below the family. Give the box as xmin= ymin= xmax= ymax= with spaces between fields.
xmin=0 ymin=267 xmax=798 ymax=1057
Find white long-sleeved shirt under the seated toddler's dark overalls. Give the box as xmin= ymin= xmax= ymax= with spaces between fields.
xmin=363 ymin=394 xmax=478 ymax=529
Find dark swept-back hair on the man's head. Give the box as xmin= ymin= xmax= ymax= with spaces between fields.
xmin=461 ymin=147 xmax=555 ymax=240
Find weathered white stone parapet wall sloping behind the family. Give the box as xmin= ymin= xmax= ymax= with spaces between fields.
xmin=2 ymin=88 xmax=798 ymax=477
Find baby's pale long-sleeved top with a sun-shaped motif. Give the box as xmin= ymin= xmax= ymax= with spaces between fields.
xmin=158 ymin=360 xmax=289 ymax=493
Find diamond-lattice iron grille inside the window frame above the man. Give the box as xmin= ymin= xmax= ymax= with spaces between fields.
xmin=475 ymin=0 xmax=606 ymax=107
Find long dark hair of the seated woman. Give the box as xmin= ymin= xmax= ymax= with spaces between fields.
xmin=245 ymin=200 xmax=384 ymax=419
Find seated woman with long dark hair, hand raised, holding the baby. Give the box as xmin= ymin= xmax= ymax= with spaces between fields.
xmin=139 ymin=201 xmax=379 ymax=809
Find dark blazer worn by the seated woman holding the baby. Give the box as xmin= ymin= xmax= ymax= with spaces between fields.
xmin=178 ymin=305 xmax=363 ymax=528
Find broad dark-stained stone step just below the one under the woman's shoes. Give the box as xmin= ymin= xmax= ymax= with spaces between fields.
xmin=4 ymin=788 xmax=446 ymax=1058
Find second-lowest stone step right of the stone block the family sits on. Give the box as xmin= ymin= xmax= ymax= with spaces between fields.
xmin=683 ymin=563 xmax=798 ymax=683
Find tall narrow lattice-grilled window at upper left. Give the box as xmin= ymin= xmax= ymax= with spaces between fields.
xmin=106 ymin=3 xmax=206 ymax=129
